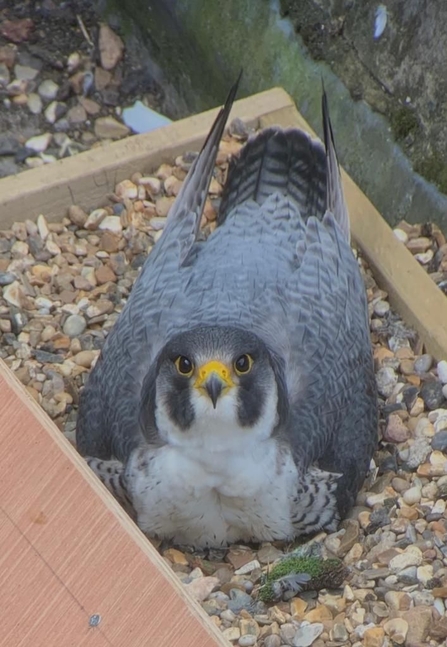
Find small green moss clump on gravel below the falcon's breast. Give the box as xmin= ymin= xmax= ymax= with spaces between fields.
xmin=259 ymin=556 xmax=346 ymax=602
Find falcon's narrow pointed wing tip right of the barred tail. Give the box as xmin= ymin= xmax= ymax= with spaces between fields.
xmin=322 ymin=89 xmax=350 ymax=241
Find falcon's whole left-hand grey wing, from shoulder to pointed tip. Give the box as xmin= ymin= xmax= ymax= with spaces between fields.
xmin=76 ymin=79 xmax=239 ymax=460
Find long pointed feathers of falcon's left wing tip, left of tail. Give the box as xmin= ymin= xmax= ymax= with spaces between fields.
xmin=164 ymin=72 xmax=242 ymax=265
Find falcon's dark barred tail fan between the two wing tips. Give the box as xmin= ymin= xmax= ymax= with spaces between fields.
xmin=219 ymin=126 xmax=326 ymax=223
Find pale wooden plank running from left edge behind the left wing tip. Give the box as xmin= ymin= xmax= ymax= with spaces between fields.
xmin=0 ymin=88 xmax=293 ymax=229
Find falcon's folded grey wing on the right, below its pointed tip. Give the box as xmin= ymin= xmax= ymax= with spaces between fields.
xmin=287 ymin=212 xmax=377 ymax=516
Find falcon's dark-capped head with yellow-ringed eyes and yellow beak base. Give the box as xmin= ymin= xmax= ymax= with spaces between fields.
xmin=141 ymin=326 xmax=287 ymax=447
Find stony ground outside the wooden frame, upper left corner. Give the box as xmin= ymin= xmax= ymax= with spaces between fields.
xmin=0 ymin=0 xmax=172 ymax=177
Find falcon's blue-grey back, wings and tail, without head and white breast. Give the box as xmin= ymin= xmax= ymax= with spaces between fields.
xmin=77 ymin=83 xmax=377 ymax=511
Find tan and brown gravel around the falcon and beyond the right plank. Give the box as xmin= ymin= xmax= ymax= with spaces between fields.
xmin=0 ymin=122 xmax=447 ymax=647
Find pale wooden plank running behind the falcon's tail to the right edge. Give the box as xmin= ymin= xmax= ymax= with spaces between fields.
xmin=260 ymin=106 xmax=447 ymax=360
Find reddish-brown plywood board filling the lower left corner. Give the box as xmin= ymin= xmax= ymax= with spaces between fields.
xmin=0 ymin=361 xmax=228 ymax=647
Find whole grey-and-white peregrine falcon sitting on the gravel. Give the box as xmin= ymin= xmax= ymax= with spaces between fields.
xmin=77 ymin=78 xmax=377 ymax=547
